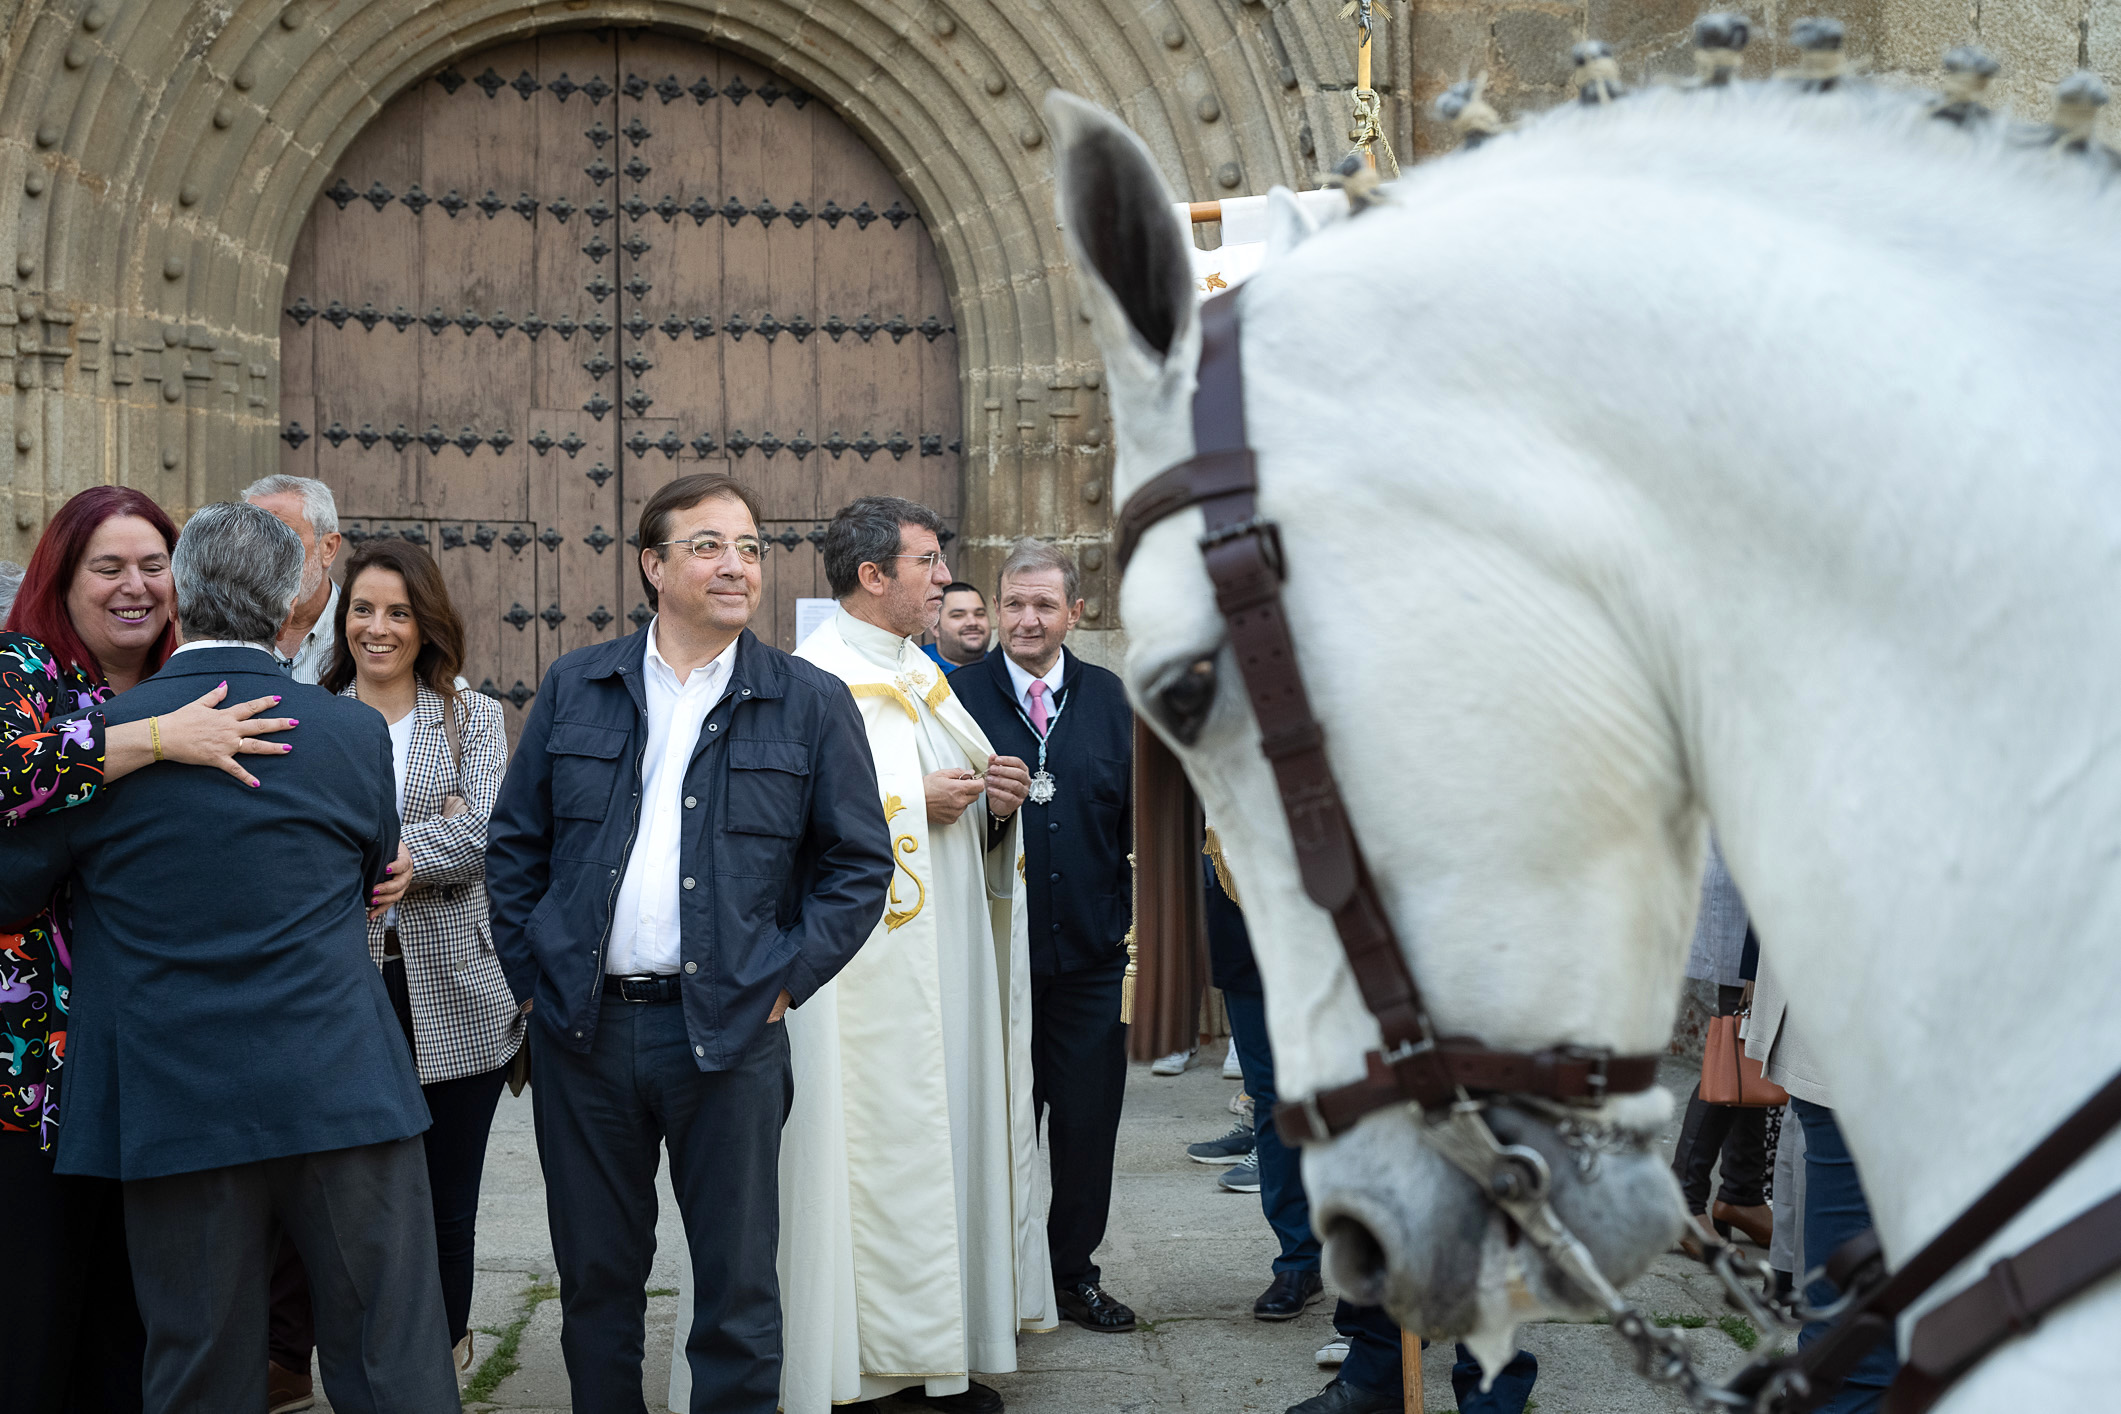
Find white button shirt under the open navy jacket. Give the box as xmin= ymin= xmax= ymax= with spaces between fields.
xmin=604 ymin=619 xmax=736 ymax=977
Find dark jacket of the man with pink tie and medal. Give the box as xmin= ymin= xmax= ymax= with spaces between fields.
xmin=950 ymin=649 xmax=1135 ymax=977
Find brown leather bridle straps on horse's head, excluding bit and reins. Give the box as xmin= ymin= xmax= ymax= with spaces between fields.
xmin=1118 ymin=290 xmax=1659 ymax=1145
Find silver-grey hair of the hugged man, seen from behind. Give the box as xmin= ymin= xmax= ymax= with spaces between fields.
xmin=170 ymin=502 xmax=303 ymax=644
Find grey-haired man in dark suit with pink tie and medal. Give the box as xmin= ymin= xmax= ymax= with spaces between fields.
xmin=948 ymin=538 xmax=1135 ymax=1331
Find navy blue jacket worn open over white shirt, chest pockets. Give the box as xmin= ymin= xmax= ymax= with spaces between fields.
xmin=486 ymin=628 xmax=891 ymax=1071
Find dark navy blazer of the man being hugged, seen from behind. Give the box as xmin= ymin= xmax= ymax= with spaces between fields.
xmin=0 ymin=649 xmax=428 ymax=1179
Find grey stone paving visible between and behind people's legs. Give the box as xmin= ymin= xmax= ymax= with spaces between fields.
xmin=318 ymin=1056 xmax=1750 ymax=1414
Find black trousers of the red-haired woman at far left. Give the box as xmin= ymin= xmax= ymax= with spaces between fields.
xmin=0 ymin=1132 xmax=146 ymax=1414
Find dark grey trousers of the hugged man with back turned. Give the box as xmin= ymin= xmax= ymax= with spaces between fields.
xmin=125 ymin=1136 xmax=456 ymax=1414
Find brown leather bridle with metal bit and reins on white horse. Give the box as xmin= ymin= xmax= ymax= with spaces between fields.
xmin=1118 ymin=281 xmax=2121 ymax=1414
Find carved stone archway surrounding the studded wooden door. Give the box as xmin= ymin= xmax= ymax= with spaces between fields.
xmin=0 ymin=0 xmax=1391 ymax=628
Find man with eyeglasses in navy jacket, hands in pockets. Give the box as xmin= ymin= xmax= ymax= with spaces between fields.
xmin=486 ymin=475 xmax=891 ymax=1414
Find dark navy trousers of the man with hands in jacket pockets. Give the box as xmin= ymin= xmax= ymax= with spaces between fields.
xmin=530 ymin=1001 xmax=795 ymax=1414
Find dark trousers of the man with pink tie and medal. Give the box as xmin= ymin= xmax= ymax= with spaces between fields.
xmin=1031 ymin=962 xmax=1126 ymax=1287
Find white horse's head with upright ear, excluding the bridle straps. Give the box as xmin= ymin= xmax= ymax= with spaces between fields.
xmin=1048 ymin=93 xmax=1703 ymax=1363
